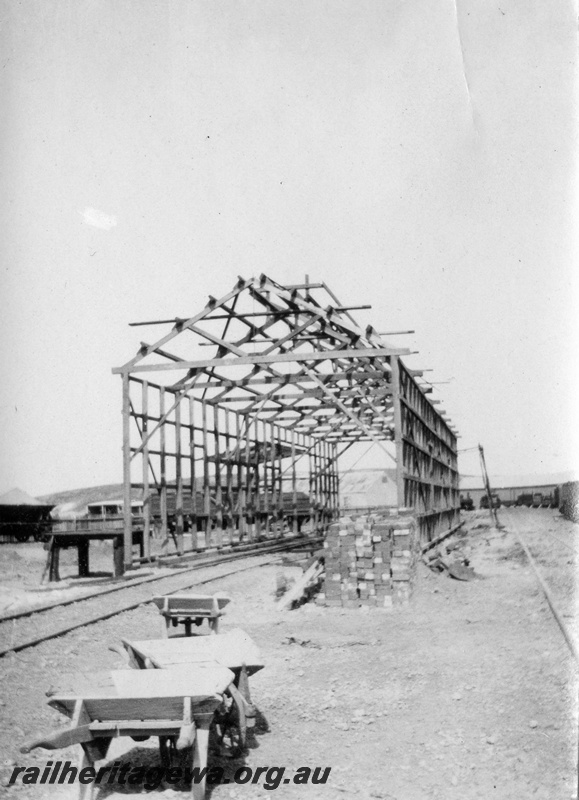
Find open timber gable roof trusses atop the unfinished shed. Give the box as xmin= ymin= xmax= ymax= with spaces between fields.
xmin=113 ymin=275 xmax=454 ymax=442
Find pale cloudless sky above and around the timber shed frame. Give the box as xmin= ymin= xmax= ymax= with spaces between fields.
xmin=0 ymin=0 xmax=579 ymax=495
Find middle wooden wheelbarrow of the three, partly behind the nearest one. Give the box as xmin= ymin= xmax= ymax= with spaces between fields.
xmin=111 ymin=628 xmax=264 ymax=756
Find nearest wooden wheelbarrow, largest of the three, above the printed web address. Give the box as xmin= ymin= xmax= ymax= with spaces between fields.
xmin=20 ymin=665 xmax=233 ymax=800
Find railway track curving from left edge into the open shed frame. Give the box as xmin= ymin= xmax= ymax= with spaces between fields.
xmin=0 ymin=539 xmax=316 ymax=658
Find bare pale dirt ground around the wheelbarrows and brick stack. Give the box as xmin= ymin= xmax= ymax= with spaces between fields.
xmin=0 ymin=509 xmax=579 ymax=800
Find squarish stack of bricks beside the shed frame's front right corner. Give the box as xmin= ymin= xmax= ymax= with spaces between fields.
xmin=318 ymin=512 xmax=417 ymax=608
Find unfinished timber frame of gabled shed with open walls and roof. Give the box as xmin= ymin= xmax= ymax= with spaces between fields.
xmin=113 ymin=275 xmax=460 ymax=567
